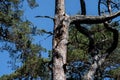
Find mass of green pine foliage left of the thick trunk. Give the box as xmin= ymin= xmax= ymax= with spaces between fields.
xmin=0 ymin=0 xmax=49 ymax=80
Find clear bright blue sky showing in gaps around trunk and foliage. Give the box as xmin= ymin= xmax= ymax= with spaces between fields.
xmin=0 ymin=0 xmax=97 ymax=76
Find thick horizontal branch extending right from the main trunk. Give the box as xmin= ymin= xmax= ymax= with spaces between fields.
xmin=69 ymin=11 xmax=120 ymax=24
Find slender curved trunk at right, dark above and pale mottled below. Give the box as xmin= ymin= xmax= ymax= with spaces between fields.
xmin=84 ymin=22 xmax=119 ymax=80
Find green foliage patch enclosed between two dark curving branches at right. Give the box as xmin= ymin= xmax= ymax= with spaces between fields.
xmin=91 ymin=24 xmax=113 ymax=53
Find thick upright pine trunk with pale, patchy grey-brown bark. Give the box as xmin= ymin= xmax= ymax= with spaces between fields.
xmin=53 ymin=0 xmax=68 ymax=80
